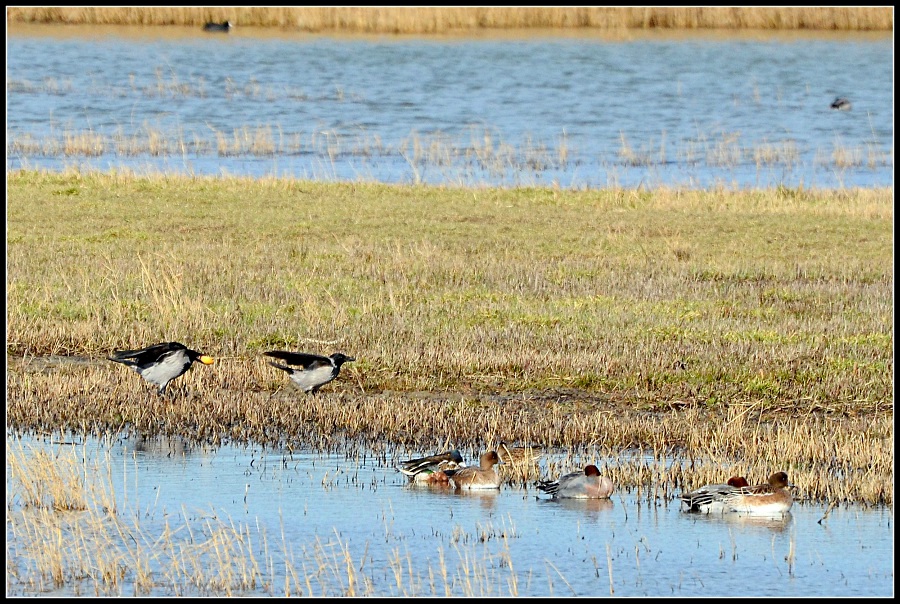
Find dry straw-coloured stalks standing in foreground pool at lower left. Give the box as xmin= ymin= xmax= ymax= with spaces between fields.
xmin=6 ymin=438 xmax=532 ymax=597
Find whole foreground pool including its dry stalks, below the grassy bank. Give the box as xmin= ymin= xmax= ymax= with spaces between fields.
xmin=7 ymin=434 xmax=893 ymax=596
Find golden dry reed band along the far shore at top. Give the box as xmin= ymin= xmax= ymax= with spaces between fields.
xmin=6 ymin=6 xmax=894 ymax=34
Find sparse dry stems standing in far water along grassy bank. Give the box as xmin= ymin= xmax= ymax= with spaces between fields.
xmin=6 ymin=114 xmax=894 ymax=177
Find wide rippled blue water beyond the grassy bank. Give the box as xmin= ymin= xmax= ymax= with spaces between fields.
xmin=7 ymin=25 xmax=894 ymax=188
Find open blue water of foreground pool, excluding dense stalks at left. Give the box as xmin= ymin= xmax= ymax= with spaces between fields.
xmin=7 ymin=436 xmax=893 ymax=597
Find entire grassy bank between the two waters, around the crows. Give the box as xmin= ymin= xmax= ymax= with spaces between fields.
xmin=7 ymin=172 xmax=894 ymax=501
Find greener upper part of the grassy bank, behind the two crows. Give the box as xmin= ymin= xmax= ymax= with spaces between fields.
xmin=7 ymin=172 xmax=893 ymax=405
